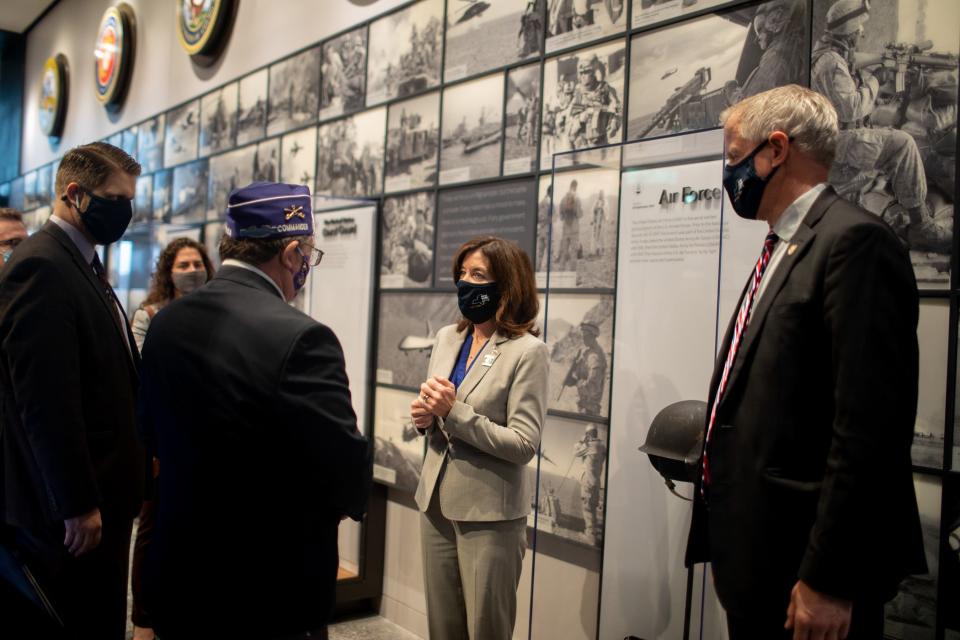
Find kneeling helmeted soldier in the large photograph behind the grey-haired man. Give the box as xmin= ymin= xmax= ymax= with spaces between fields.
xmin=811 ymin=0 xmax=953 ymax=253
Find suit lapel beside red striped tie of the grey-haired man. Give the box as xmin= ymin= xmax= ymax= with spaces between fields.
xmin=711 ymin=189 xmax=837 ymax=410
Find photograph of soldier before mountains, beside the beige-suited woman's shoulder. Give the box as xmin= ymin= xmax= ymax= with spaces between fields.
xmin=546 ymin=293 xmax=613 ymax=419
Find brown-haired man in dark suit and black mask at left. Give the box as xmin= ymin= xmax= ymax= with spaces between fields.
xmin=0 ymin=142 xmax=144 ymax=640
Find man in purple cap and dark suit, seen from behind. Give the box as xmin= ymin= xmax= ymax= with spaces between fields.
xmin=140 ymin=183 xmax=372 ymax=638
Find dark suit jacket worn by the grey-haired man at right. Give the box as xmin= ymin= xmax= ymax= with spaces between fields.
xmin=687 ymin=188 xmax=926 ymax=615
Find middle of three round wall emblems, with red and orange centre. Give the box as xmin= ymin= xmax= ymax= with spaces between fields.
xmin=93 ymin=3 xmax=135 ymax=107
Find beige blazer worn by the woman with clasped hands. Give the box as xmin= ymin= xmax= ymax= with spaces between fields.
xmin=416 ymin=325 xmax=549 ymax=522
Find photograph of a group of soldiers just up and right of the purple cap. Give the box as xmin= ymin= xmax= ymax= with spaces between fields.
xmin=315 ymin=107 xmax=387 ymax=196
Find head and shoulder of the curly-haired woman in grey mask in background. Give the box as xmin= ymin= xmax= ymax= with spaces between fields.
xmin=130 ymin=238 xmax=213 ymax=350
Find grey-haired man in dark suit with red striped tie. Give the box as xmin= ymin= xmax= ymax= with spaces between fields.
xmin=687 ymin=85 xmax=926 ymax=640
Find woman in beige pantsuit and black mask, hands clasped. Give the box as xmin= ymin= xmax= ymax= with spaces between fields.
xmin=410 ymin=236 xmax=549 ymax=640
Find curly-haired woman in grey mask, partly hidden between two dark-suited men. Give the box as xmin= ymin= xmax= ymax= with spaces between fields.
xmin=130 ymin=238 xmax=214 ymax=640
